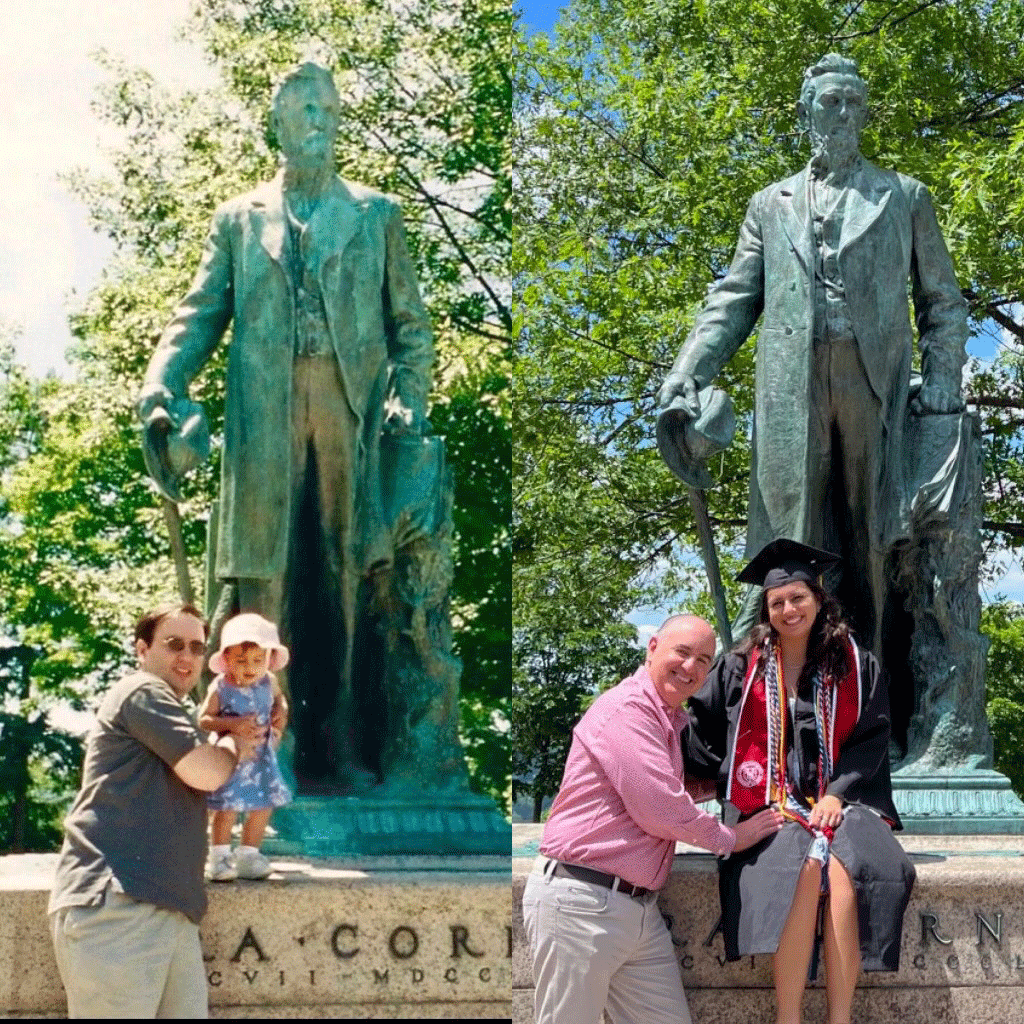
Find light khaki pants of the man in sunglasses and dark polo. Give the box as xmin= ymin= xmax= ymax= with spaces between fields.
xmin=50 ymin=889 xmax=208 ymax=1020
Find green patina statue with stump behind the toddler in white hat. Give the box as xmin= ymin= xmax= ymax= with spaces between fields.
xmin=138 ymin=63 xmax=505 ymax=852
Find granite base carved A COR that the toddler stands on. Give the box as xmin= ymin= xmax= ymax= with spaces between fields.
xmin=0 ymin=848 xmax=512 ymax=1020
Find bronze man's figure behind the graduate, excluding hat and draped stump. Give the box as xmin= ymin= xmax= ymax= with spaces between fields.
xmin=659 ymin=54 xmax=968 ymax=654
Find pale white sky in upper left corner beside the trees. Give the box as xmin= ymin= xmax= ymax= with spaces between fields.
xmin=0 ymin=0 xmax=214 ymax=374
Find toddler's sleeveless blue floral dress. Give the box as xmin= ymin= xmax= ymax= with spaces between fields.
xmin=207 ymin=675 xmax=292 ymax=811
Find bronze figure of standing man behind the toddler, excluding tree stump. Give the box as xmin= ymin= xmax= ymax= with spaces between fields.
xmin=139 ymin=63 xmax=432 ymax=793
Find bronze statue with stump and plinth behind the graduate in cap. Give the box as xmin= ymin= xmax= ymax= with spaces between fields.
xmin=658 ymin=53 xmax=1024 ymax=833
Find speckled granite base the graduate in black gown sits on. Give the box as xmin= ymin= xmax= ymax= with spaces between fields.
xmin=512 ymin=825 xmax=1024 ymax=1024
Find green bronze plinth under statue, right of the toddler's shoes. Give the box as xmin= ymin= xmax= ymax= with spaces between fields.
xmin=264 ymin=791 xmax=512 ymax=863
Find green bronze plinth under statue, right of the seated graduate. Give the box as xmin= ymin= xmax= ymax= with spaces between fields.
xmin=893 ymin=764 xmax=1024 ymax=836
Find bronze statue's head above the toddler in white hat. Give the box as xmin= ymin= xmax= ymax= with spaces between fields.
xmin=270 ymin=62 xmax=341 ymax=164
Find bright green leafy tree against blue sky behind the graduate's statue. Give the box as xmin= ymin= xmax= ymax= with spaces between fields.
xmin=513 ymin=0 xmax=1024 ymax=638
